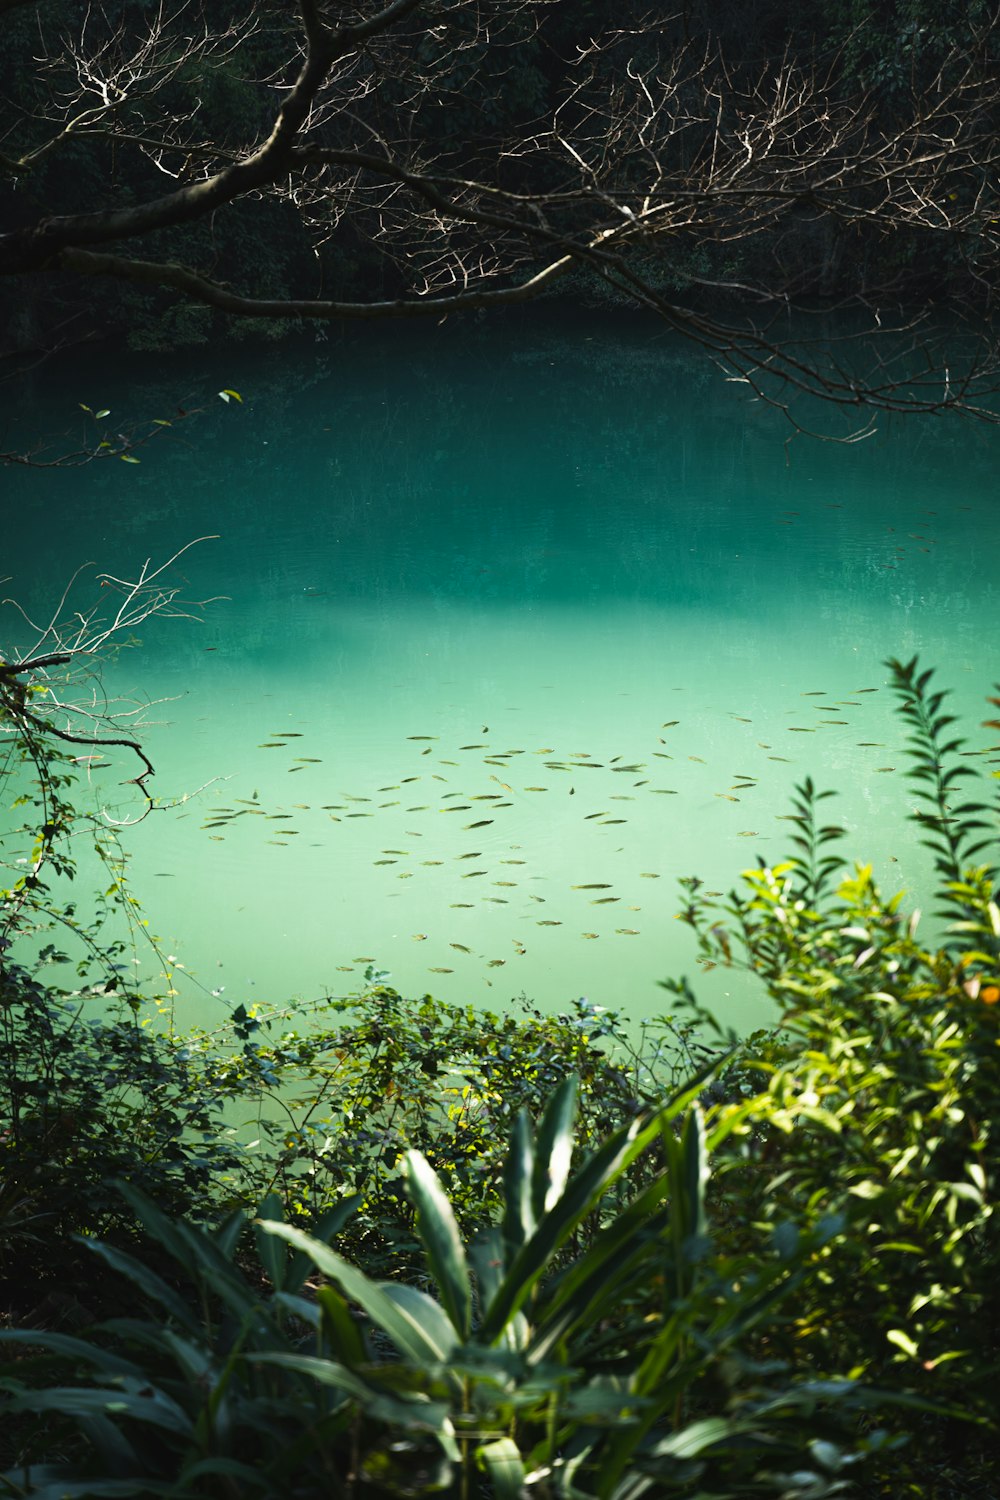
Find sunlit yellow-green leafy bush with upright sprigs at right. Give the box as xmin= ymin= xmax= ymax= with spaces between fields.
xmin=687 ymin=662 xmax=1000 ymax=1494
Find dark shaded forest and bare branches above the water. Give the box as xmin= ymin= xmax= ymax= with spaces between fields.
xmin=0 ymin=0 xmax=1000 ymax=423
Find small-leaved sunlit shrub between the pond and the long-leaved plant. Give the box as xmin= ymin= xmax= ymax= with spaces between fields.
xmin=206 ymin=971 xmax=722 ymax=1274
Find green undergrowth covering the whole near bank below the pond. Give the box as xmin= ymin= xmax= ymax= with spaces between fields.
xmin=0 ymin=662 xmax=1000 ymax=1500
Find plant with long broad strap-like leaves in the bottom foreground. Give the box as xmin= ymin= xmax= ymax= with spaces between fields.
xmin=0 ymin=1079 xmax=905 ymax=1500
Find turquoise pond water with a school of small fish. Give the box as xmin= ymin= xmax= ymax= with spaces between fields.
xmin=3 ymin=317 xmax=1000 ymax=1026
